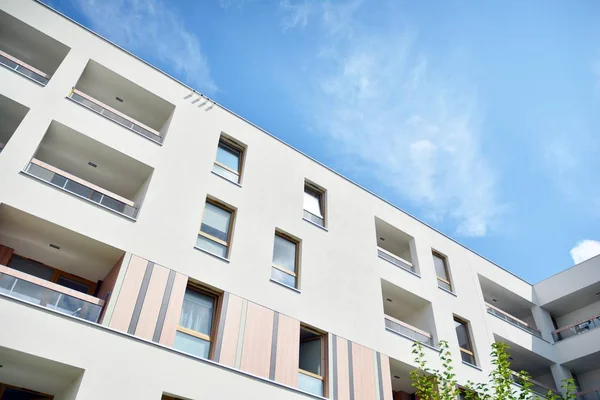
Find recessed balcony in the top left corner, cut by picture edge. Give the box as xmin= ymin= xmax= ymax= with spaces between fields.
xmin=0 ymin=11 xmax=70 ymax=86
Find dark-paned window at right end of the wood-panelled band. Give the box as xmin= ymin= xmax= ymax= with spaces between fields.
xmin=298 ymin=327 xmax=327 ymax=396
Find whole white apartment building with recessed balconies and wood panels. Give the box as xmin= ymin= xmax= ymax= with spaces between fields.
xmin=0 ymin=0 xmax=600 ymax=400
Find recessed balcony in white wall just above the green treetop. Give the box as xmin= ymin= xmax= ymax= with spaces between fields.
xmin=381 ymin=279 xmax=436 ymax=347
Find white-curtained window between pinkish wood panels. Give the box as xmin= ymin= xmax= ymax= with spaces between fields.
xmin=173 ymin=287 xmax=217 ymax=358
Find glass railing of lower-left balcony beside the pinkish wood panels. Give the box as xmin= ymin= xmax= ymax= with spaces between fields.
xmin=0 ymin=265 xmax=104 ymax=322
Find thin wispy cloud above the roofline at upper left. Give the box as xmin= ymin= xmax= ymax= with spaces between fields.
xmin=73 ymin=0 xmax=217 ymax=94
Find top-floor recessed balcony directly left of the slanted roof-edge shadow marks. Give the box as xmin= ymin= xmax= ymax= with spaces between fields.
xmin=68 ymin=60 xmax=175 ymax=144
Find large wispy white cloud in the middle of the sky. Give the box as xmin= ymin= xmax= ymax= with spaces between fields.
xmin=282 ymin=1 xmax=504 ymax=236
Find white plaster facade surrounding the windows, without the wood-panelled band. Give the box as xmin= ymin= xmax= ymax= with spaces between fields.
xmin=0 ymin=0 xmax=600 ymax=400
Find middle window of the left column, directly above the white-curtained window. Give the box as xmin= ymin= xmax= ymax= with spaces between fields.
xmin=196 ymin=200 xmax=233 ymax=258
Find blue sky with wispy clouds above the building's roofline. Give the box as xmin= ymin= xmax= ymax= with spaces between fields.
xmin=47 ymin=0 xmax=600 ymax=283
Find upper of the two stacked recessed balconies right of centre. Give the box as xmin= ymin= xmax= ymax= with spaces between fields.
xmin=375 ymin=217 xmax=418 ymax=275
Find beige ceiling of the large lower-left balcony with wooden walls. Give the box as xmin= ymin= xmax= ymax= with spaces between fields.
xmin=0 ymin=204 xmax=124 ymax=281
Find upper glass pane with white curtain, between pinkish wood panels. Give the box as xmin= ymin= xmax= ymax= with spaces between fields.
xmin=179 ymin=289 xmax=215 ymax=336
